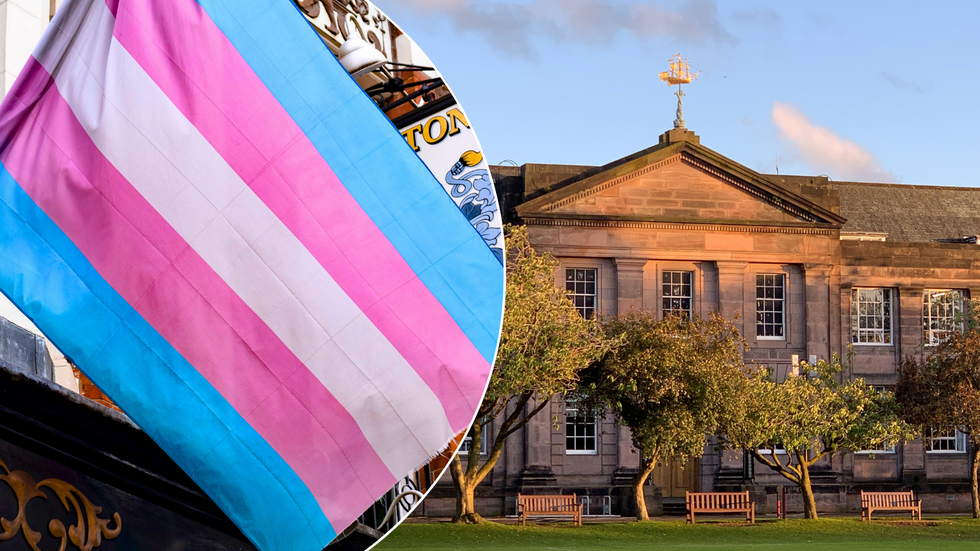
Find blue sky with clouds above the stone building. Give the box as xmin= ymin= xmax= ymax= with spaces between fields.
xmin=375 ymin=0 xmax=980 ymax=187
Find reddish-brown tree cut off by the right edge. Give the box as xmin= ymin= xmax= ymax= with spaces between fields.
xmin=895 ymin=305 xmax=980 ymax=518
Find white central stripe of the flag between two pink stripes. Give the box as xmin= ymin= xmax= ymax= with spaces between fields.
xmin=37 ymin=0 xmax=452 ymax=476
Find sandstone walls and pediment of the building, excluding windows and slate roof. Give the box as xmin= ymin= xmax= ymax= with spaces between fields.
xmin=446 ymin=141 xmax=980 ymax=514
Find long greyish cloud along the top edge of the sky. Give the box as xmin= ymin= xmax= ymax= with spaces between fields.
xmin=389 ymin=0 xmax=738 ymax=58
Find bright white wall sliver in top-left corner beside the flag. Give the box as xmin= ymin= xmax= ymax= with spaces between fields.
xmin=0 ymin=0 xmax=51 ymax=94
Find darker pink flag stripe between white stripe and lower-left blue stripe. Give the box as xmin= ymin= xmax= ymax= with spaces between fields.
xmin=0 ymin=58 xmax=401 ymax=518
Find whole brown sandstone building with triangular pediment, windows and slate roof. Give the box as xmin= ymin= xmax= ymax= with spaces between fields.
xmin=425 ymin=129 xmax=980 ymax=515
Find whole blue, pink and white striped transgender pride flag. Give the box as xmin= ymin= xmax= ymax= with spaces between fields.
xmin=0 ymin=0 xmax=503 ymax=550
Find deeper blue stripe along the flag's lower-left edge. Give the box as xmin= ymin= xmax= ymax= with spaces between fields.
xmin=0 ymin=165 xmax=336 ymax=551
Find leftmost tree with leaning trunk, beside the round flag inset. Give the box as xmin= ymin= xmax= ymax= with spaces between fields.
xmin=450 ymin=226 xmax=610 ymax=523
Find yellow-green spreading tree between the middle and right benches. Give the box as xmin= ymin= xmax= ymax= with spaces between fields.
xmin=719 ymin=354 xmax=914 ymax=519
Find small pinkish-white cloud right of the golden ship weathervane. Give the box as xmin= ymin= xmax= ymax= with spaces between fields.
xmin=772 ymin=102 xmax=896 ymax=182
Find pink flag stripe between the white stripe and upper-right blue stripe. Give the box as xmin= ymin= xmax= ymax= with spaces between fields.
xmin=114 ymin=0 xmax=490 ymax=431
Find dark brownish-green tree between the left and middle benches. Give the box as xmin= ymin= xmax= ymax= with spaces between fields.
xmin=582 ymin=311 xmax=745 ymax=520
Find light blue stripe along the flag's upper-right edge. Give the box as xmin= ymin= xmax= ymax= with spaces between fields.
xmin=197 ymin=0 xmax=504 ymax=362
